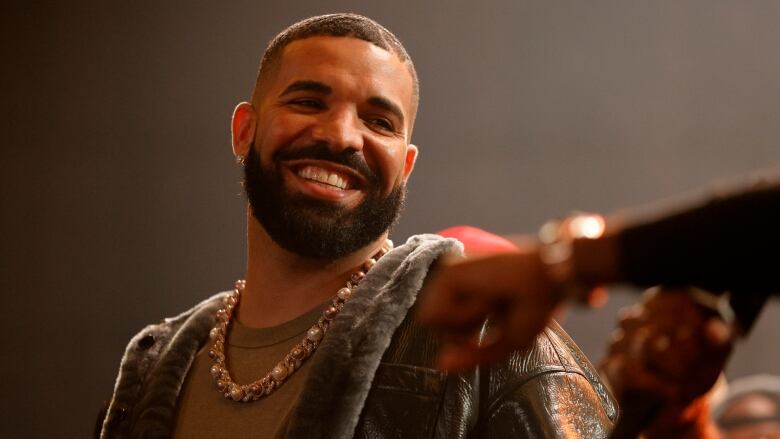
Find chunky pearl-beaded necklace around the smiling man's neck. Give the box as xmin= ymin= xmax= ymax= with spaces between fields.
xmin=209 ymin=239 xmax=393 ymax=402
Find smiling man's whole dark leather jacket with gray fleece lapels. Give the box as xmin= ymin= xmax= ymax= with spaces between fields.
xmin=98 ymin=235 xmax=617 ymax=439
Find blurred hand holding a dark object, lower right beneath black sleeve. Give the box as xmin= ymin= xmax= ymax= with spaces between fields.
xmin=601 ymin=288 xmax=735 ymax=438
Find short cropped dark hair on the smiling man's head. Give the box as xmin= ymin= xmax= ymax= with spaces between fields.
xmin=255 ymin=13 xmax=420 ymax=111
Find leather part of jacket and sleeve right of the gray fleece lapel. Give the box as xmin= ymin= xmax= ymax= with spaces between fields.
xmin=355 ymin=312 xmax=617 ymax=439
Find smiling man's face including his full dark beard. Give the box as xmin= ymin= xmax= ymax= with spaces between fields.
xmin=245 ymin=37 xmax=416 ymax=259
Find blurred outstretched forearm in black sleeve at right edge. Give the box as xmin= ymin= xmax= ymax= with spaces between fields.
xmin=574 ymin=179 xmax=780 ymax=293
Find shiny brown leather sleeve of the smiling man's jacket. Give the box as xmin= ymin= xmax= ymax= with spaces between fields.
xmin=478 ymin=323 xmax=617 ymax=439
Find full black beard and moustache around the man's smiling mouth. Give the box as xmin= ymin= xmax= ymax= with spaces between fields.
xmin=244 ymin=145 xmax=406 ymax=261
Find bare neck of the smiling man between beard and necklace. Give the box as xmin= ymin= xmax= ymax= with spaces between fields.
xmin=237 ymin=213 xmax=387 ymax=328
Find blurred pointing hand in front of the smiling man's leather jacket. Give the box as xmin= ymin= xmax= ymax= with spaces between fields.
xmin=417 ymin=245 xmax=560 ymax=371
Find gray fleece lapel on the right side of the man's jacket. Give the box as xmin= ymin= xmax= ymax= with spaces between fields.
xmin=287 ymin=235 xmax=462 ymax=439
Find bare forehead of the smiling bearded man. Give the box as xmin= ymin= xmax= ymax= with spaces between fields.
xmin=269 ymin=36 xmax=413 ymax=112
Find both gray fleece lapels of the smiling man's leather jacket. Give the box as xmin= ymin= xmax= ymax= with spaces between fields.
xmin=102 ymin=235 xmax=462 ymax=439
